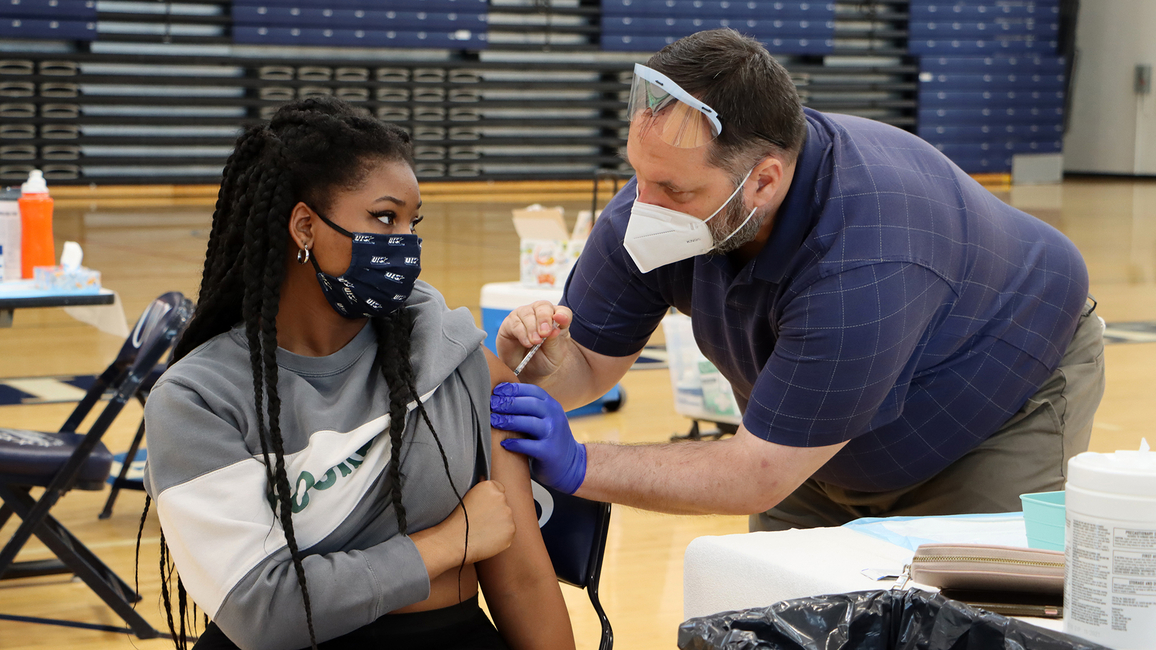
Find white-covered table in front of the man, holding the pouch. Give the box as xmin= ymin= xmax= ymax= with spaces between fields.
xmin=682 ymin=517 xmax=1064 ymax=630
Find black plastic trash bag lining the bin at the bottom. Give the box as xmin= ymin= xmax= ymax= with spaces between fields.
xmin=679 ymin=590 xmax=1109 ymax=650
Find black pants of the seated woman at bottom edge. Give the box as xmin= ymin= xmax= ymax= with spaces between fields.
xmin=193 ymin=596 xmax=510 ymax=650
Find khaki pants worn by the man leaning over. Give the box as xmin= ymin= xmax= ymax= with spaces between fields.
xmin=750 ymin=308 xmax=1104 ymax=531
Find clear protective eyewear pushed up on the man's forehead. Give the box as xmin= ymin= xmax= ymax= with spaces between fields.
xmin=627 ymin=64 xmax=723 ymax=149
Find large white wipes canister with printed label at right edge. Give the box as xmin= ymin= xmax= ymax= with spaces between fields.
xmin=1064 ymin=443 xmax=1156 ymax=650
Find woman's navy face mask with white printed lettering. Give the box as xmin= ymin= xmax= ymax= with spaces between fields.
xmin=310 ymin=210 xmax=422 ymax=318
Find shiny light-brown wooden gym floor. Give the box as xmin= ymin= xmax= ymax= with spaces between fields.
xmin=0 ymin=178 xmax=1156 ymax=650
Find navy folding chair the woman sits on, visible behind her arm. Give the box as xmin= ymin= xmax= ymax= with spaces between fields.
xmin=531 ymin=481 xmax=614 ymax=650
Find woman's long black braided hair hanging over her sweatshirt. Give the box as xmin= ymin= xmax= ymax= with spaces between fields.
xmin=136 ymin=97 xmax=469 ymax=650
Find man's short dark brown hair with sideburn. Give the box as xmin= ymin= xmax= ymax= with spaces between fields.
xmin=646 ymin=29 xmax=807 ymax=178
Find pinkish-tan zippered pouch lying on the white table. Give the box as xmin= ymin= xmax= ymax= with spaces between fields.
xmin=911 ymin=544 xmax=1064 ymax=593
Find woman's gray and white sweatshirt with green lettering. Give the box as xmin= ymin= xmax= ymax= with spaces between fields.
xmin=145 ymin=282 xmax=490 ymax=650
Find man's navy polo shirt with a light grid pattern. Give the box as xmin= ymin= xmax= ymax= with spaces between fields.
xmin=563 ymin=110 xmax=1088 ymax=492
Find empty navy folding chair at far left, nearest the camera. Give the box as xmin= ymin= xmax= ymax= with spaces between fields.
xmin=0 ymin=293 xmax=193 ymax=638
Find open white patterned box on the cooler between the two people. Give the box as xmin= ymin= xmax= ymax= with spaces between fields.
xmin=513 ymin=204 xmax=593 ymax=287
